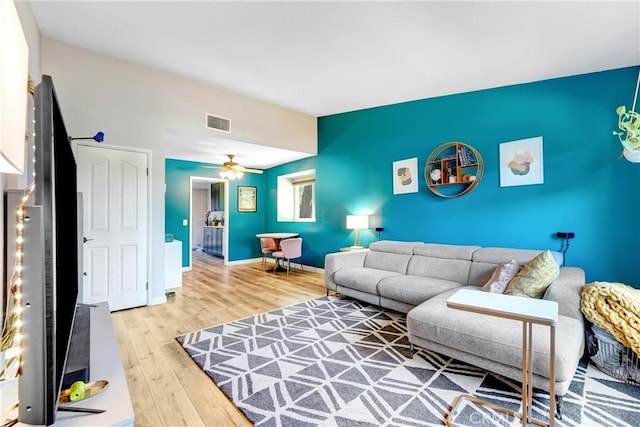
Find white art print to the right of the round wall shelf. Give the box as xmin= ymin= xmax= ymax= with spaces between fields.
xmin=500 ymin=136 xmax=544 ymax=187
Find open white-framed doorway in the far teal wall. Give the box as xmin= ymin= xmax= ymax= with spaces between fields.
xmin=188 ymin=176 xmax=229 ymax=270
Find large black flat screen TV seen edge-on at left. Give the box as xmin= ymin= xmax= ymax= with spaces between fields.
xmin=18 ymin=75 xmax=79 ymax=425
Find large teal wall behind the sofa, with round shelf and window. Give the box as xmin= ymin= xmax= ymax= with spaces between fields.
xmin=262 ymin=67 xmax=640 ymax=287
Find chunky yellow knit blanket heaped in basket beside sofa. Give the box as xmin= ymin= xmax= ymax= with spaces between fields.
xmin=580 ymin=282 xmax=640 ymax=357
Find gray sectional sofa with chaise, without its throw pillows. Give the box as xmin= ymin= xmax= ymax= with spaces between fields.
xmin=325 ymin=241 xmax=585 ymax=414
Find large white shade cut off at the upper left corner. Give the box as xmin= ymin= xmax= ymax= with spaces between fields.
xmin=0 ymin=0 xmax=29 ymax=174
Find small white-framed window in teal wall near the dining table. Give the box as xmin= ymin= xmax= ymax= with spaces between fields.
xmin=278 ymin=169 xmax=316 ymax=222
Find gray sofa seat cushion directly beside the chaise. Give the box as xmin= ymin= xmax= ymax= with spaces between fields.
xmin=378 ymin=275 xmax=460 ymax=305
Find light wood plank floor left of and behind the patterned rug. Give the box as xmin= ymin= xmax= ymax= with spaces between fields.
xmin=112 ymin=252 xmax=326 ymax=427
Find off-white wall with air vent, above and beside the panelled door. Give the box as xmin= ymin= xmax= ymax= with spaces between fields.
xmin=41 ymin=38 xmax=317 ymax=303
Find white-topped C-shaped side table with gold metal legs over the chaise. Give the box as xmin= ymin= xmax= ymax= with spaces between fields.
xmin=447 ymin=289 xmax=558 ymax=427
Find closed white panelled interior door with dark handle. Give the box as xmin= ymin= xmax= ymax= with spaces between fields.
xmin=77 ymin=144 xmax=148 ymax=311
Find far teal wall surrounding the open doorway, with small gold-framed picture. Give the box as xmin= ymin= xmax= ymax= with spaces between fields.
xmin=165 ymin=159 xmax=266 ymax=267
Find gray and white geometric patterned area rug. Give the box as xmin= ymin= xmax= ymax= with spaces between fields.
xmin=176 ymin=295 xmax=640 ymax=427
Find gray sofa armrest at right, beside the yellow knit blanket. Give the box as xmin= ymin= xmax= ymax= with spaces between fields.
xmin=544 ymin=267 xmax=585 ymax=320
